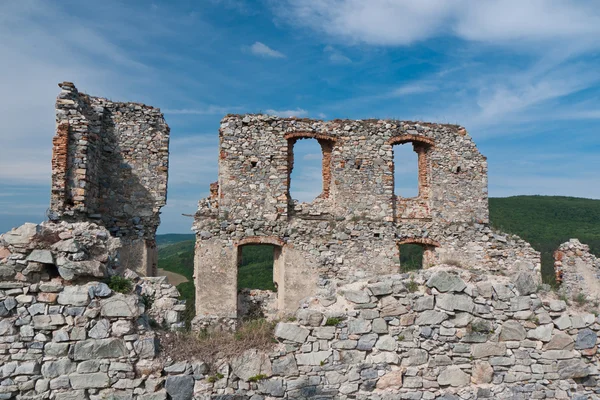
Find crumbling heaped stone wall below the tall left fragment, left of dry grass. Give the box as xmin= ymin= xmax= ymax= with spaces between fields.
xmin=0 ymin=221 xmax=185 ymax=400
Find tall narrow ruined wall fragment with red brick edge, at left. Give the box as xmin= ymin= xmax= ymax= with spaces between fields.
xmin=50 ymin=82 xmax=169 ymax=275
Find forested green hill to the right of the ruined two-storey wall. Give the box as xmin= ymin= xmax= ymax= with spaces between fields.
xmin=490 ymin=196 xmax=600 ymax=284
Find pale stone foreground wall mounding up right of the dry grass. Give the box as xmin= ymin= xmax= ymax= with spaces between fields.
xmin=184 ymin=266 xmax=600 ymax=400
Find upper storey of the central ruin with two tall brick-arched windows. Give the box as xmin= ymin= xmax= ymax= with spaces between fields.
xmin=213 ymin=115 xmax=488 ymax=228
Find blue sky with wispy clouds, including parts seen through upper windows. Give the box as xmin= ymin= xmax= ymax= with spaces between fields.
xmin=0 ymin=0 xmax=600 ymax=233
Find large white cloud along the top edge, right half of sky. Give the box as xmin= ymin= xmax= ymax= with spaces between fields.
xmin=271 ymin=0 xmax=600 ymax=50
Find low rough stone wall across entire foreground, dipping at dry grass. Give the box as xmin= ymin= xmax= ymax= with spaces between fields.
xmin=0 ymin=222 xmax=600 ymax=400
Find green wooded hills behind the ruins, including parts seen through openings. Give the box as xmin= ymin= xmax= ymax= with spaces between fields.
xmin=157 ymin=196 xmax=600 ymax=318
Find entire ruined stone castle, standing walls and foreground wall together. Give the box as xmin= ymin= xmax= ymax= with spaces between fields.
xmin=0 ymin=82 xmax=600 ymax=400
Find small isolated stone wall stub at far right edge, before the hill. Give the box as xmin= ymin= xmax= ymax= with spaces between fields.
xmin=554 ymin=239 xmax=600 ymax=302
